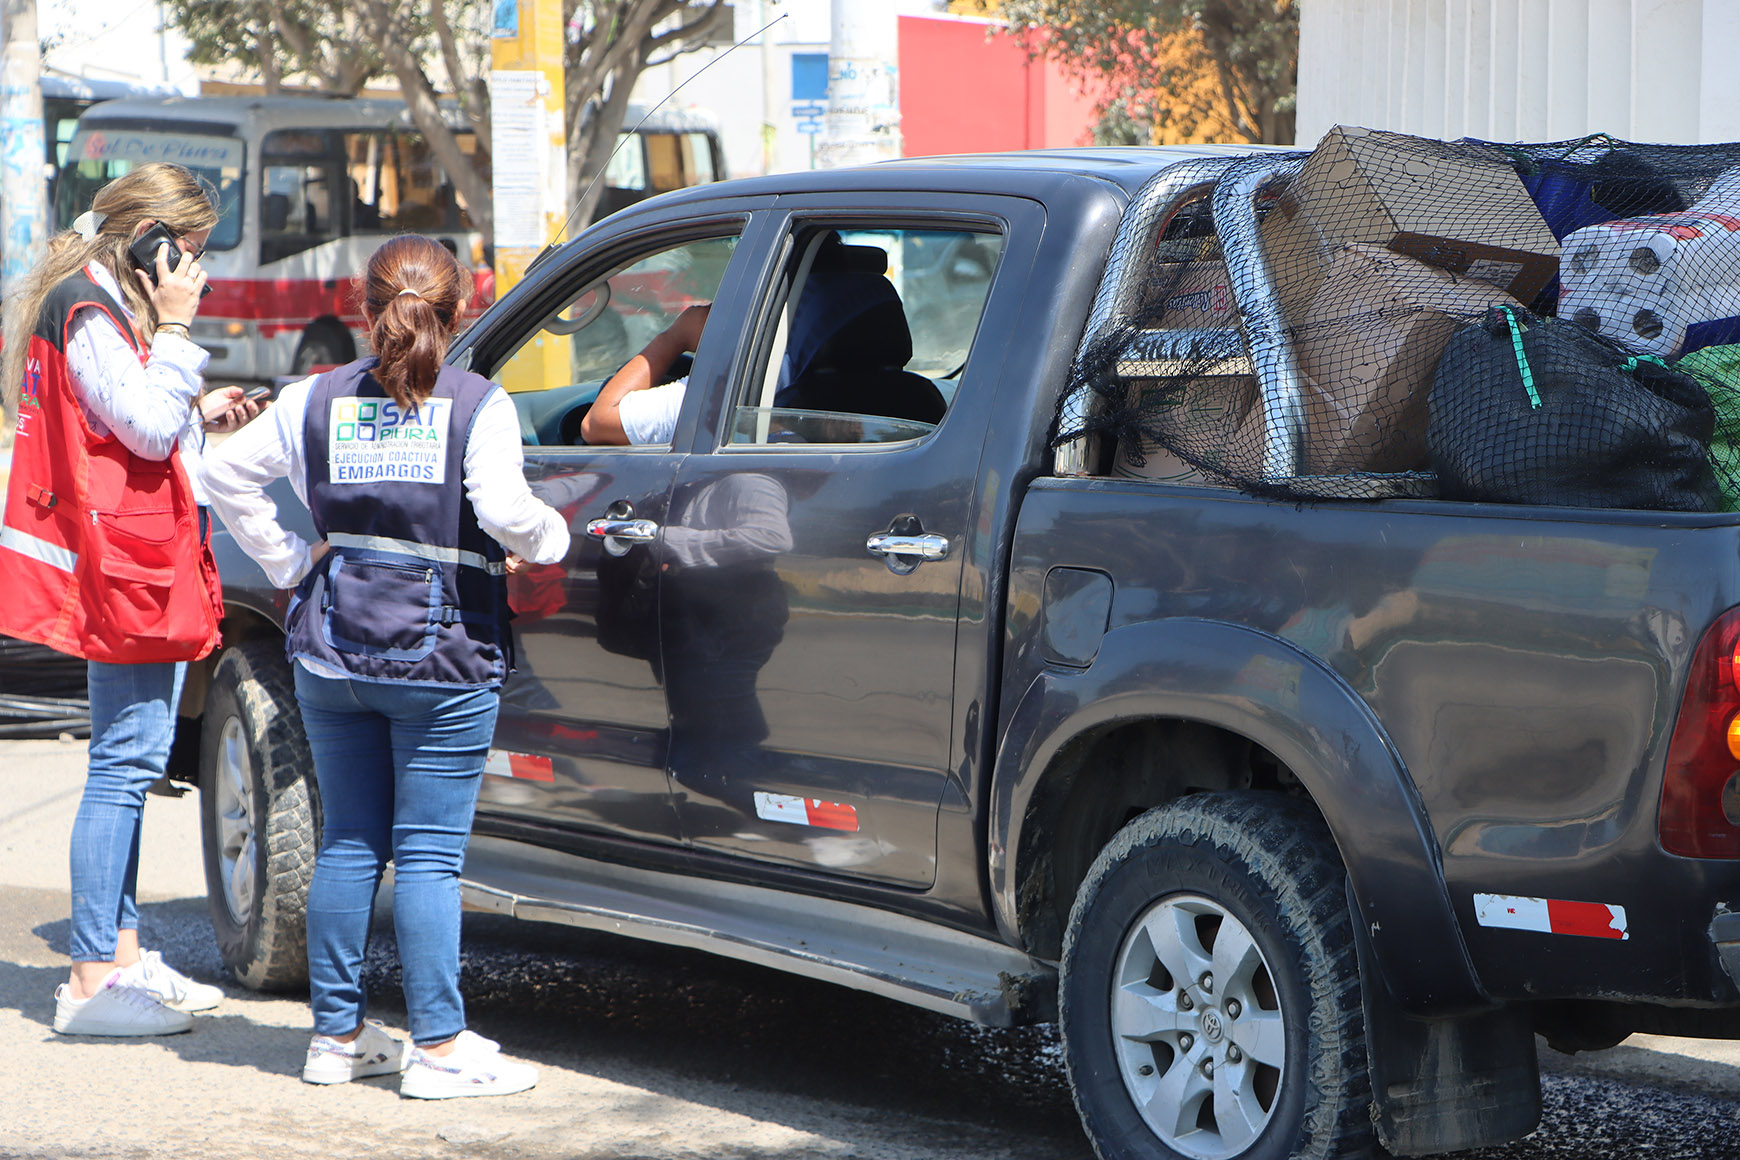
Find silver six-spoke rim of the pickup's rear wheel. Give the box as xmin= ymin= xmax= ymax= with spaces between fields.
xmin=1112 ymin=894 xmax=1286 ymax=1160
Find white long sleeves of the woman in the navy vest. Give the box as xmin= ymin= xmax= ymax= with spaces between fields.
xmin=205 ymin=377 xmax=569 ymax=588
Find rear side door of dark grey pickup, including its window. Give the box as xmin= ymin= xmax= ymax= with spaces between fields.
xmin=659 ymin=195 xmax=1044 ymax=887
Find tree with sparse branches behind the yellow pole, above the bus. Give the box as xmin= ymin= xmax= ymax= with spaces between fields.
xmin=171 ymin=0 xmax=726 ymax=243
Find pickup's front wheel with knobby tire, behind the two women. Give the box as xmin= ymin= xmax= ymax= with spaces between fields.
xmin=200 ymin=640 xmax=320 ymax=991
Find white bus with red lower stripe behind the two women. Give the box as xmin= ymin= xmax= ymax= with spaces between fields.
xmin=54 ymin=97 xmax=494 ymax=379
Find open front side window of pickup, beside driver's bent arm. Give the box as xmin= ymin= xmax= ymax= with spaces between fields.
xmin=491 ymin=233 xmax=738 ymax=445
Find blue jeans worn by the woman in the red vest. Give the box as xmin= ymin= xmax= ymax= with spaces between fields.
xmin=71 ymin=661 xmax=188 ymax=962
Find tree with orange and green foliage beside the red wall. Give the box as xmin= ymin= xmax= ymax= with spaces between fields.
xmin=999 ymin=0 xmax=1300 ymax=144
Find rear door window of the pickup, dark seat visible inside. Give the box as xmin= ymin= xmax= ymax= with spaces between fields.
xmin=731 ymin=226 xmax=1002 ymax=443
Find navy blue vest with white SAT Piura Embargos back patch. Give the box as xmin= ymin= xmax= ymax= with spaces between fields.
xmin=287 ymin=357 xmax=513 ymax=689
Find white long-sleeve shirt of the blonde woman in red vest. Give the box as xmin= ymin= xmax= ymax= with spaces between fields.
xmin=66 ymin=263 xmax=211 ymax=503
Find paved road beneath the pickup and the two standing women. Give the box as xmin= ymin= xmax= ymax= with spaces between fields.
xmin=10 ymin=741 xmax=1740 ymax=1160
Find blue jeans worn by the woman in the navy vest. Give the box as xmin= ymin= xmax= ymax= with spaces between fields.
xmin=294 ymin=664 xmax=501 ymax=1045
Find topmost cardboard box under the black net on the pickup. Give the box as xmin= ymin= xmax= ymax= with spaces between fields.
xmin=1262 ymin=125 xmax=1559 ymax=325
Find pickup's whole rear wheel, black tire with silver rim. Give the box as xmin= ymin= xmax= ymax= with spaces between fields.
xmin=1058 ymin=793 xmax=1373 ymax=1160
